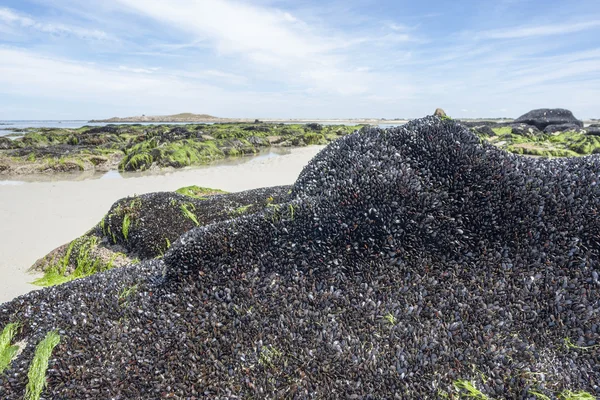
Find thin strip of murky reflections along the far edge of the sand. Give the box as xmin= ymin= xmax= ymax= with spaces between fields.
xmin=0 ymin=147 xmax=292 ymax=185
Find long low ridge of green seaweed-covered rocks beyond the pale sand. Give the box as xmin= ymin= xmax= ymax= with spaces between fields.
xmin=0 ymin=123 xmax=361 ymax=174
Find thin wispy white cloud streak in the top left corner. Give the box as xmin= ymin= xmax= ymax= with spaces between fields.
xmin=0 ymin=8 xmax=110 ymax=40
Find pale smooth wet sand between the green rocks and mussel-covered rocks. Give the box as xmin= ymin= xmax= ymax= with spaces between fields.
xmin=0 ymin=146 xmax=323 ymax=303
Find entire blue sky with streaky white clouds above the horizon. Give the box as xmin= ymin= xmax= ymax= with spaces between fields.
xmin=0 ymin=0 xmax=600 ymax=119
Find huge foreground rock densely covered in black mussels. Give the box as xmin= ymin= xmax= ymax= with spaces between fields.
xmin=0 ymin=117 xmax=600 ymax=399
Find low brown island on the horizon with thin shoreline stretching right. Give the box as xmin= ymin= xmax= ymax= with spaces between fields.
xmin=89 ymin=113 xmax=408 ymax=125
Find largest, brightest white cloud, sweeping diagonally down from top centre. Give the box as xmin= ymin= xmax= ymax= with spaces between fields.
xmin=112 ymin=0 xmax=392 ymax=94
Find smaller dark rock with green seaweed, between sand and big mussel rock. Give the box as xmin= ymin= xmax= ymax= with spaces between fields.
xmin=31 ymin=186 xmax=291 ymax=286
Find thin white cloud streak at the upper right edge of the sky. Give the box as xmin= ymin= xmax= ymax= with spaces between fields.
xmin=477 ymin=21 xmax=600 ymax=39
